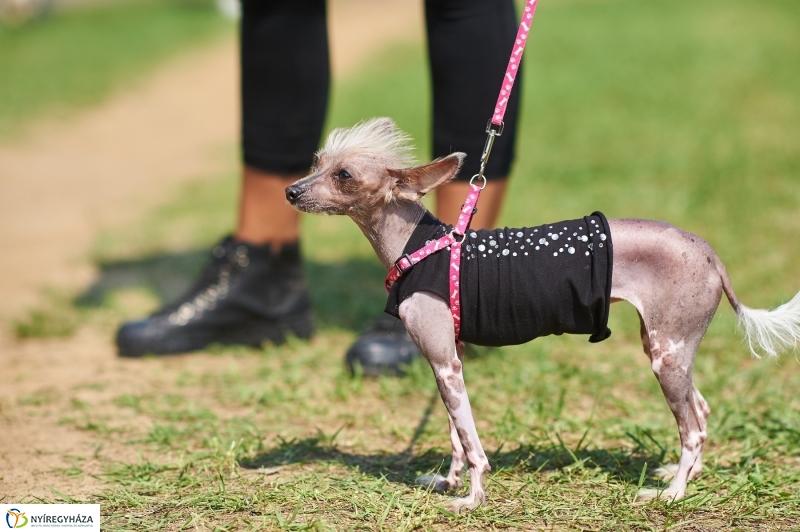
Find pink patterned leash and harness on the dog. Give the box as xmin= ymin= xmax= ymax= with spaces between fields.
xmin=384 ymin=0 xmax=538 ymax=343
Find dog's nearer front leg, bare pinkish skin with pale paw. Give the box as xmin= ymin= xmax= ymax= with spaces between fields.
xmin=400 ymin=292 xmax=491 ymax=512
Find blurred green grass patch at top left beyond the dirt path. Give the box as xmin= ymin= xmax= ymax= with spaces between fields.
xmin=0 ymin=0 xmax=230 ymax=138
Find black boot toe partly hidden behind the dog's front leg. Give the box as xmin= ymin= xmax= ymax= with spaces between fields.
xmin=345 ymin=314 xmax=420 ymax=377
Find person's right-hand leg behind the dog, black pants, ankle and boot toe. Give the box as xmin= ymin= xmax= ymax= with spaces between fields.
xmin=346 ymin=0 xmax=519 ymax=375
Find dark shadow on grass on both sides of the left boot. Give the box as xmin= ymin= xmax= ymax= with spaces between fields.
xmin=74 ymin=249 xmax=386 ymax=331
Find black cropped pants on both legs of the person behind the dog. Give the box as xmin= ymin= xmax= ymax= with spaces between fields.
xmin=241 ymin=0 xmax=520 ymax=180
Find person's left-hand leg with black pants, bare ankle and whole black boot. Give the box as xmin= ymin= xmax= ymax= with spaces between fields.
xmin=117 ymin=0 xmax=330 ymax=356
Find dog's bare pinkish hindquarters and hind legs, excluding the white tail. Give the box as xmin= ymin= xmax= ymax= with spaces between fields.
xmin=609 ymin=220 xmax=723 ymax=500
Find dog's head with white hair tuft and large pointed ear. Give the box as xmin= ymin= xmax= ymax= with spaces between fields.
xmin=286 ymin=118 xmax=465 ymax=218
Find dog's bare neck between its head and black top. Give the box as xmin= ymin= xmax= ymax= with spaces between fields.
xmin=353 ymin=201 xmax=427 ymax=271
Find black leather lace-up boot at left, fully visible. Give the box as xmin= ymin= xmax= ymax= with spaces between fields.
xmin=117 ymin=237 xmax=313 ymax=357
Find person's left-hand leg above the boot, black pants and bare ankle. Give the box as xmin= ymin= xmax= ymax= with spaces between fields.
xmin=236 ymin=0 xmax=330 ymax=246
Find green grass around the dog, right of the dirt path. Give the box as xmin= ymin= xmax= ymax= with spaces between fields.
xmin=9 ymin=0 xmax=800 ymax=531
